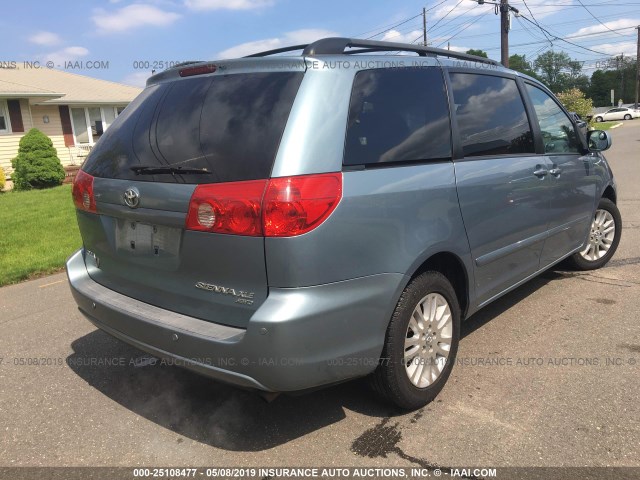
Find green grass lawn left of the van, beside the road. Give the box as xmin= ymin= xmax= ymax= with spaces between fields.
xmin=0 ymin=185 xmax=82 ymax=286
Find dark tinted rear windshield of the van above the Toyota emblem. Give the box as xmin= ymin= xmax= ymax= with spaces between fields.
xmin=83 ymin=72 xmax=303 ymax=183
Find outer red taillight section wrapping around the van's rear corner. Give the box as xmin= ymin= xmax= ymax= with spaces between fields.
xmin=262 ymin=173 xmax=342 ymax=237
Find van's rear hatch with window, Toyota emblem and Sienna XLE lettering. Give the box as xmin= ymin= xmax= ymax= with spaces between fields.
xmin=78 ymin=60 xmax=303 ymax=327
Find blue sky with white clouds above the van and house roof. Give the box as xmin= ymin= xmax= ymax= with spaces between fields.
xmin=0 ymin=0 xmax=640 ymax=86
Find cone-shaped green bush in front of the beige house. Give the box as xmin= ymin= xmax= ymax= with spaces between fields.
xmin=11 ymin=128 xmax=64 ymax=190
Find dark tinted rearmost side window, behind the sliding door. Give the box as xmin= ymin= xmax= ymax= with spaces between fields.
xmin=344 ymin=67 xmax=451 ymax=165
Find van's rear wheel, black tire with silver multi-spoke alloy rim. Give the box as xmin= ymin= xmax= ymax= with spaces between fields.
xmin=370 ymin=271 xmax=460 ymax=410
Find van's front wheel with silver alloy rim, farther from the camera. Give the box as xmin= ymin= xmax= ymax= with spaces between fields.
xmin=568 ymin=198 xmax=622 ymax=270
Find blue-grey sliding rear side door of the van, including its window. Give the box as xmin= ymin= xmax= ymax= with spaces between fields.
xmin=450 ymin=71 xmax=549 ymax=304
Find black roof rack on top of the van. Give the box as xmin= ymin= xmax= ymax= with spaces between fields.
xmin=247 ymin=37 xmax=501 ymax=66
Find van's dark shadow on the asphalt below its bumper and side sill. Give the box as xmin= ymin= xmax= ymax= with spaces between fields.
xmin=67 ymin=272 xmax=562 ymax=452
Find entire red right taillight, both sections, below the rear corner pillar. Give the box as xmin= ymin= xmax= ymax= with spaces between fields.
xmin=186 ymin=173 xmax=342 ymax=237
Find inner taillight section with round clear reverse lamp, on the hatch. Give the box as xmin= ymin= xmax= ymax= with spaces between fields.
xmin=187 ymin=180 xmax=267 ymax=237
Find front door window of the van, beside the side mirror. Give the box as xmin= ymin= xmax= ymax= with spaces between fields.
xmin=526 ymin=83 xmax=582 ymax=153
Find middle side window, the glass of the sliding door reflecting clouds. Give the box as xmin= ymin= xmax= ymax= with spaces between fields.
xmin=451 ymin=73 xmax=535 ymax=157
